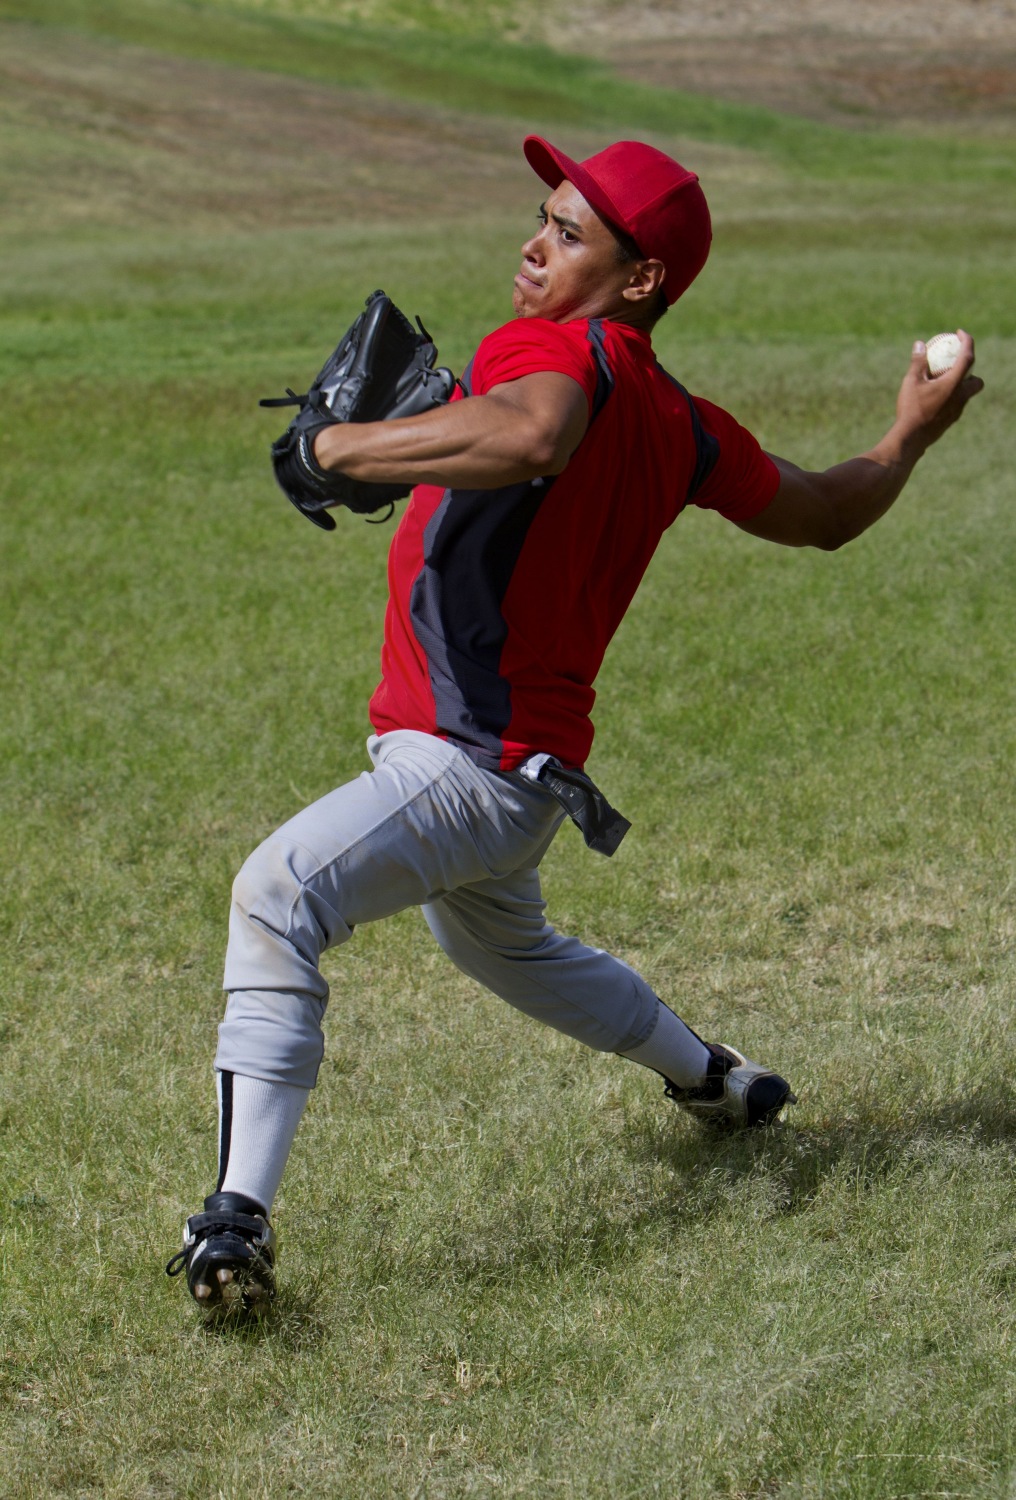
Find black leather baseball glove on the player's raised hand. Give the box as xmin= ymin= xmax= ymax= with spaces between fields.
xmin=261 ymin=291 xmax=455 ymax=531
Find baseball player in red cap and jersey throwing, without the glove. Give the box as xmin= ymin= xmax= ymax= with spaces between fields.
xmin=167 ymin=137 xmax=981 ymax=1308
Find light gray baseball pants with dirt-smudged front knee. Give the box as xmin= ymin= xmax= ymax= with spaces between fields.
xmin=215 ymin=729 xmax=659 ymax=1089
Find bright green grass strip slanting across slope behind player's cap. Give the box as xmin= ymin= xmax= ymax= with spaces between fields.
xmin=0 ymin=0 xmax=1013 ymax=185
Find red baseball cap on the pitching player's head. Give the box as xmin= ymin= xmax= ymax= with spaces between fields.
xmin=522 ymin=135 xmax=713 ymax=303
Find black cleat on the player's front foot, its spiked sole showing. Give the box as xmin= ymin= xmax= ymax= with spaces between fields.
xmin=165 ymin=1193 xmax=275 ymax=1313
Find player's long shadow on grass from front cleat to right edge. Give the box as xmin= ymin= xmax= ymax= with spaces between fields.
xmin=190 ymin=1088 xmax=1016 ymax=1326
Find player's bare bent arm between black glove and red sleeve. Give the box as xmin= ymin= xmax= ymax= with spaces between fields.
xmin=314 ymin=396 xmax=569 ymax=489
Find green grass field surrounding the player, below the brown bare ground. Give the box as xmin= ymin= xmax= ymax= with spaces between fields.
xmin=0 ymin=0 xmax=1016 ymax=1500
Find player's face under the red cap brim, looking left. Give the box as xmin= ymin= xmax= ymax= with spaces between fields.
xmin=512 ymin=182 xmax=632 ymax=323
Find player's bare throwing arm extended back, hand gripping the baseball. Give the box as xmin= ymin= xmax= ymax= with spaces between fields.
xmin=737 ymin=332 xmax=984 ymax=552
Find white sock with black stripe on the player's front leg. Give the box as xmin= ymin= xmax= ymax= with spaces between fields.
xmin=216 ymin=1073 xmax=311 ymax=1214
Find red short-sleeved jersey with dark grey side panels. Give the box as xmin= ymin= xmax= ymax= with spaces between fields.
xmin=369 ymin=318 xmax=779 ymax=771
